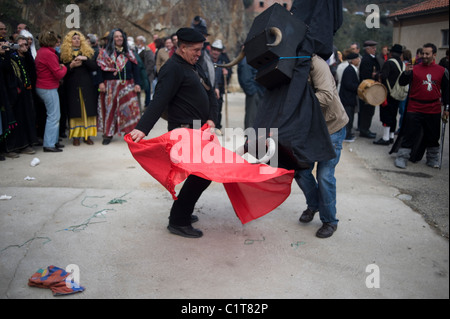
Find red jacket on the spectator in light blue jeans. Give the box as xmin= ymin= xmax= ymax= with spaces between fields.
xmin=35 ymin=47 xmax=67 ymax=90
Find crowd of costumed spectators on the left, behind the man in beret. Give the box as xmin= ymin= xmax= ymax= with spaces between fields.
xmin=0 ymin=16 xmax=231 ymax=160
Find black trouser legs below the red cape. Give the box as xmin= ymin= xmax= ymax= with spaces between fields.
xmin=169 ymin=175 xmax=211 ymax=226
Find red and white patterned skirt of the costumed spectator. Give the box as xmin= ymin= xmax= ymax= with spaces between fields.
xmin=98 ymin=80 xmax=141 ymax=137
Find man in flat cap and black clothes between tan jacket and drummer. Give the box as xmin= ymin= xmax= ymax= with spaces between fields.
xmin=339 ymin=53 xmax=361 ymax=142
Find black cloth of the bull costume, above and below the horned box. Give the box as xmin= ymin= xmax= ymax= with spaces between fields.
xmin=253 ymin=0 xmax=343 ymax=169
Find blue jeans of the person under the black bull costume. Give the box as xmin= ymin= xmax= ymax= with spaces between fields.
xmin=295 ymin=127 xmax=346 ymax=225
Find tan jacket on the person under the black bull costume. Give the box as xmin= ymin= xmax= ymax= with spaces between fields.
xmin=309 ymin=55 xmax=349 ymax=135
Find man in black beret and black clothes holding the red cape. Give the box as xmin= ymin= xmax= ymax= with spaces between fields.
xmin=130 ymin=28 xmax=217 ymax=238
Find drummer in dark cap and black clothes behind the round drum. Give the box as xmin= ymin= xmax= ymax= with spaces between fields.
xmin=358 ymin=40 xmax=380 ymax=138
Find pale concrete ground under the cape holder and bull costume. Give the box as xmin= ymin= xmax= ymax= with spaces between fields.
xmin=0 ymin=93 xmax=449 ymax=299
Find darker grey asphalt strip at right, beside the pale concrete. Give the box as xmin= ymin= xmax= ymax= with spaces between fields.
xmin=352 ymin=108 xmax=449 ymax=239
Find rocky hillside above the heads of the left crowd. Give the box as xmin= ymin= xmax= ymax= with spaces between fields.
xmin=5 ymin=0 xmax=254 ymax=56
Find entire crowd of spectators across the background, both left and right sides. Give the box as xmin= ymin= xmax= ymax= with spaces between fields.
xmin=0 ymin=16 xmax=449 ymax=168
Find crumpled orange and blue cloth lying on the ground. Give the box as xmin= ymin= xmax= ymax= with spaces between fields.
xmin=28 ymin=266 xmax=85 ymax=296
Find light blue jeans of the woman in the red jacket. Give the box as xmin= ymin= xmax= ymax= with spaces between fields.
xmin=36 ymin=88 xmax=61 ymax=147
